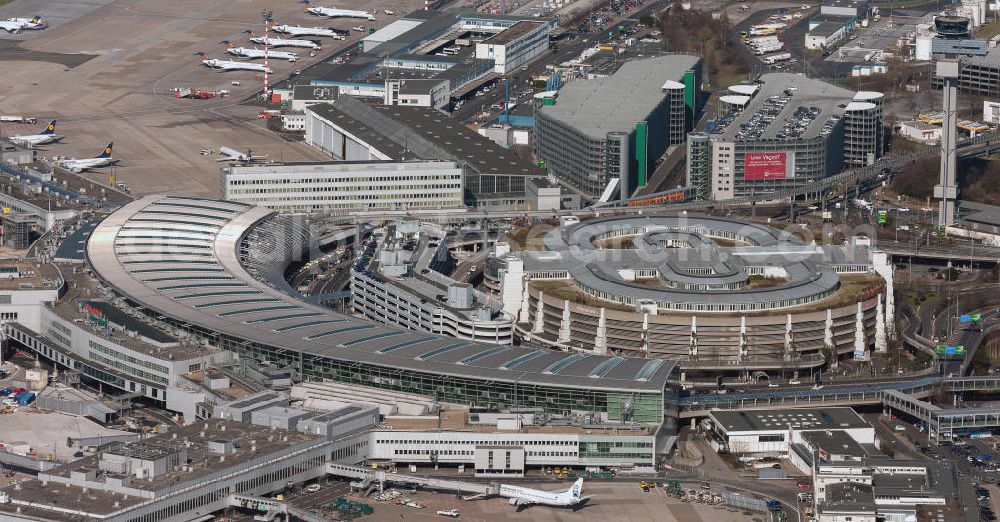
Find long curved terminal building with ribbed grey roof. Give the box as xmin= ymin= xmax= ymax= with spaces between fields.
xmin=87 ymin=196 xmax=675 ymax=423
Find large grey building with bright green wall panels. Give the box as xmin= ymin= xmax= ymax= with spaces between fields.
xmin=535 ymin=55 xmax=702 ymax=199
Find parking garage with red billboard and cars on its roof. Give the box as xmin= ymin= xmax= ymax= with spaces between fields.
xmin=688 ymin=73 xmax=883 ymax=200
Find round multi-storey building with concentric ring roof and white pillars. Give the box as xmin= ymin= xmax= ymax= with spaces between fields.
xmin=487 ymin=215 xmax=893 ymax=370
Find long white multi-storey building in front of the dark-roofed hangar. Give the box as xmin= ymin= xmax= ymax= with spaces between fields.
xmin=220 ymin=161 xmax=465 ymax=213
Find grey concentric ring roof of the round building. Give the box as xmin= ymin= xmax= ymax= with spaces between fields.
xmin=516 ymin=214 xmax=877 ymax=313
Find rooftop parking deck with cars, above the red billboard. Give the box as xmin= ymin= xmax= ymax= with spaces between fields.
xmin=712 ymin=73 xmax=856 ymax=142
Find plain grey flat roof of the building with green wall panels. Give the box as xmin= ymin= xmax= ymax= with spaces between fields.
xmin=540 ymin=54 xmax=700 ymax=140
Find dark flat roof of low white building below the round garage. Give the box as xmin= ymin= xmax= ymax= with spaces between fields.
xmin=708 ymin=408 xmax=871 ymax=433
